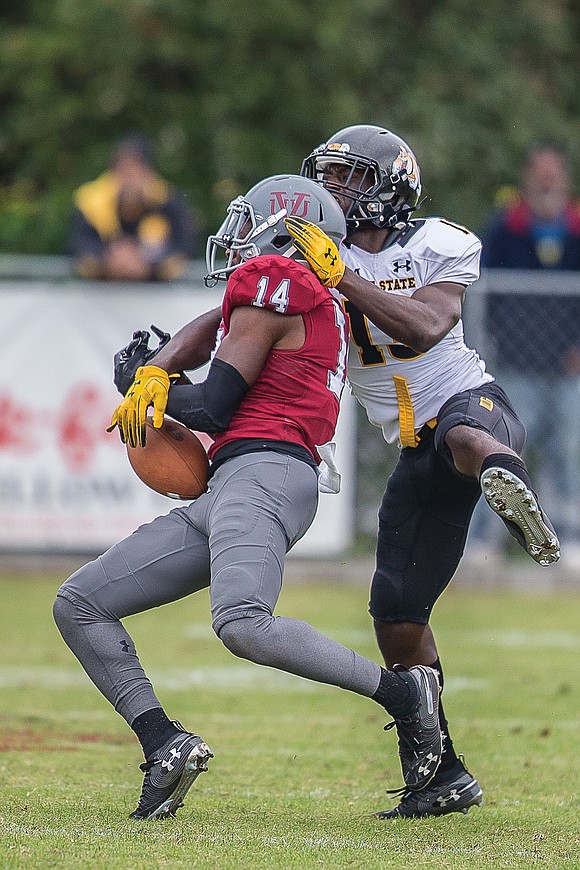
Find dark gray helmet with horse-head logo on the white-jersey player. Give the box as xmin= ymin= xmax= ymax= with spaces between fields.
xmin=300 ymin=124 xmax=421 ymax=232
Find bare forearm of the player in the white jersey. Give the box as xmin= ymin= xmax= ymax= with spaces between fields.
xmin=337 ymin=268 xmax=450 ymax=353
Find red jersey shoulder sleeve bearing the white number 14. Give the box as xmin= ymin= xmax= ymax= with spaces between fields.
xmin=226 ymin=255 xmax=329 ymax=314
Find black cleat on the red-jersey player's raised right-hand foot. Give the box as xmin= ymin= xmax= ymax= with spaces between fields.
xmin=385 ymin=665 xmax=443 ymax=790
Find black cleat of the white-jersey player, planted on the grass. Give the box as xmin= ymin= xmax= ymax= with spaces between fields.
xmin=375 ymin=762 xmax=483 ymax=819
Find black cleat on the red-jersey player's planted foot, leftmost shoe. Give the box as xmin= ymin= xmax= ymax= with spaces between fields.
xmin=130 ymin=723 xmax=213 ymax=819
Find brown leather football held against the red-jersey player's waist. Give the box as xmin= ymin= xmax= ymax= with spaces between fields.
xmin=127 ymin=417 xmax=209 ymax=500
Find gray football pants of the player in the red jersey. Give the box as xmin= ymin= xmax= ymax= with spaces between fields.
xmin=54 ymin=452 xmax=381 ymax=724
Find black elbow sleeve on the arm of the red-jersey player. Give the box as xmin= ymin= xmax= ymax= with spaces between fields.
xmin=166 ymin=359 xmax=250 ymax=434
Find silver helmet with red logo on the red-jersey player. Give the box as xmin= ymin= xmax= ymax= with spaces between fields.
xmin=205 ymin=175 xmax=346 ymax=287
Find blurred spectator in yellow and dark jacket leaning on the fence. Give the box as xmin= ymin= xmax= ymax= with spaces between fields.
xmin=70 ymin=133 xmax=196 ymax=281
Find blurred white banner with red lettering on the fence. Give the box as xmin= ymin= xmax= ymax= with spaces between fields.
xmin=0 ymin=281 xmax=354 ymax=556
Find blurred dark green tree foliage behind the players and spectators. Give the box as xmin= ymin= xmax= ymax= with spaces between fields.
xmin=0 ymin=0 xmax=580 ymax=253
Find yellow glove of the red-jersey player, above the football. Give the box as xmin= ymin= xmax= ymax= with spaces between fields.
xmin=107 ymin=366 xmax=179 ymax=447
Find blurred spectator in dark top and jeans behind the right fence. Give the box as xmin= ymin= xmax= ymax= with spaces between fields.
xmin=482 ymin=143 xmax=580 ymax=562
